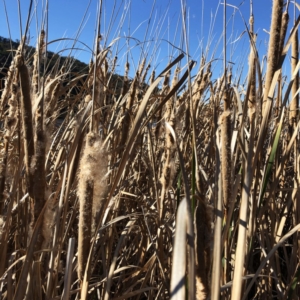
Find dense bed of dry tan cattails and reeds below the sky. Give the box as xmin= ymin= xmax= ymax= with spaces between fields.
xmin=0 ymin=0 xmax=300 ymax=300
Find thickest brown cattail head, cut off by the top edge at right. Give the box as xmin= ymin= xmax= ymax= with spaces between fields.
xmin=262 ymin=0 xmax=283 ymax=115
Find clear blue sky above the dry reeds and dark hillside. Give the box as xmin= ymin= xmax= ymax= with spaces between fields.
xmin=0 ymin=0 xmax=293 ymax=81
